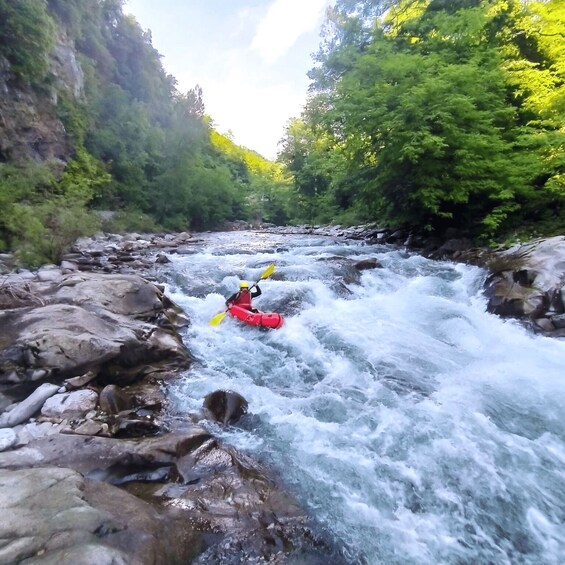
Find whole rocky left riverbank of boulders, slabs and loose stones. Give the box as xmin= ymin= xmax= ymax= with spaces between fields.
xmin=0 ymin=234 xmax=338 ymax=565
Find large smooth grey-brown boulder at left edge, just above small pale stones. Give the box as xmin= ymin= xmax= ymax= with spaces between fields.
xmin=0 ymin=304 xmax=188 ymax=383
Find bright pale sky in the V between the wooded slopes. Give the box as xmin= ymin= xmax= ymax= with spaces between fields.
xmin=123 ymin=0 xmax=331 ymax=159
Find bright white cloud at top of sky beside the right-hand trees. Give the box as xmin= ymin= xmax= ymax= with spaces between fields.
xmin=251 ymin=0 xmax=328 ymax=64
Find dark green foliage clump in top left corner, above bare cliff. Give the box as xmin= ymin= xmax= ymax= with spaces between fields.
xmin=0 ymin=0 xmax=55 ymax=82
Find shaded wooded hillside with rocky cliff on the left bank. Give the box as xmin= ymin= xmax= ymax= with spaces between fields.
xmin=0 ymin=0 xmax=289 ymax=264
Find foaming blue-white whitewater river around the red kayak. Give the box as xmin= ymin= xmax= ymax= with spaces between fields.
xmin=162 ymin=232 xmax=565 ymax=565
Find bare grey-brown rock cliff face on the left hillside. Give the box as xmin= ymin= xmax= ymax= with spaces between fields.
xmin=0 ymin=31 xmax=84 ymax=163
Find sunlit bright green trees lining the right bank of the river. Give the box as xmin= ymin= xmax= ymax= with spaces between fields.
xmin=281 ymin=0 xmax=565 ymax=240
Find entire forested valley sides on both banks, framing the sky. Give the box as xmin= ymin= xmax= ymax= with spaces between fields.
xmin=0 ymin=0 xmax=565 ymax=264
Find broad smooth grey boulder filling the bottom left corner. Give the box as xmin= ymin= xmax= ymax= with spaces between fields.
xmin=0 ymin=467 xmax=198 ymax=565
